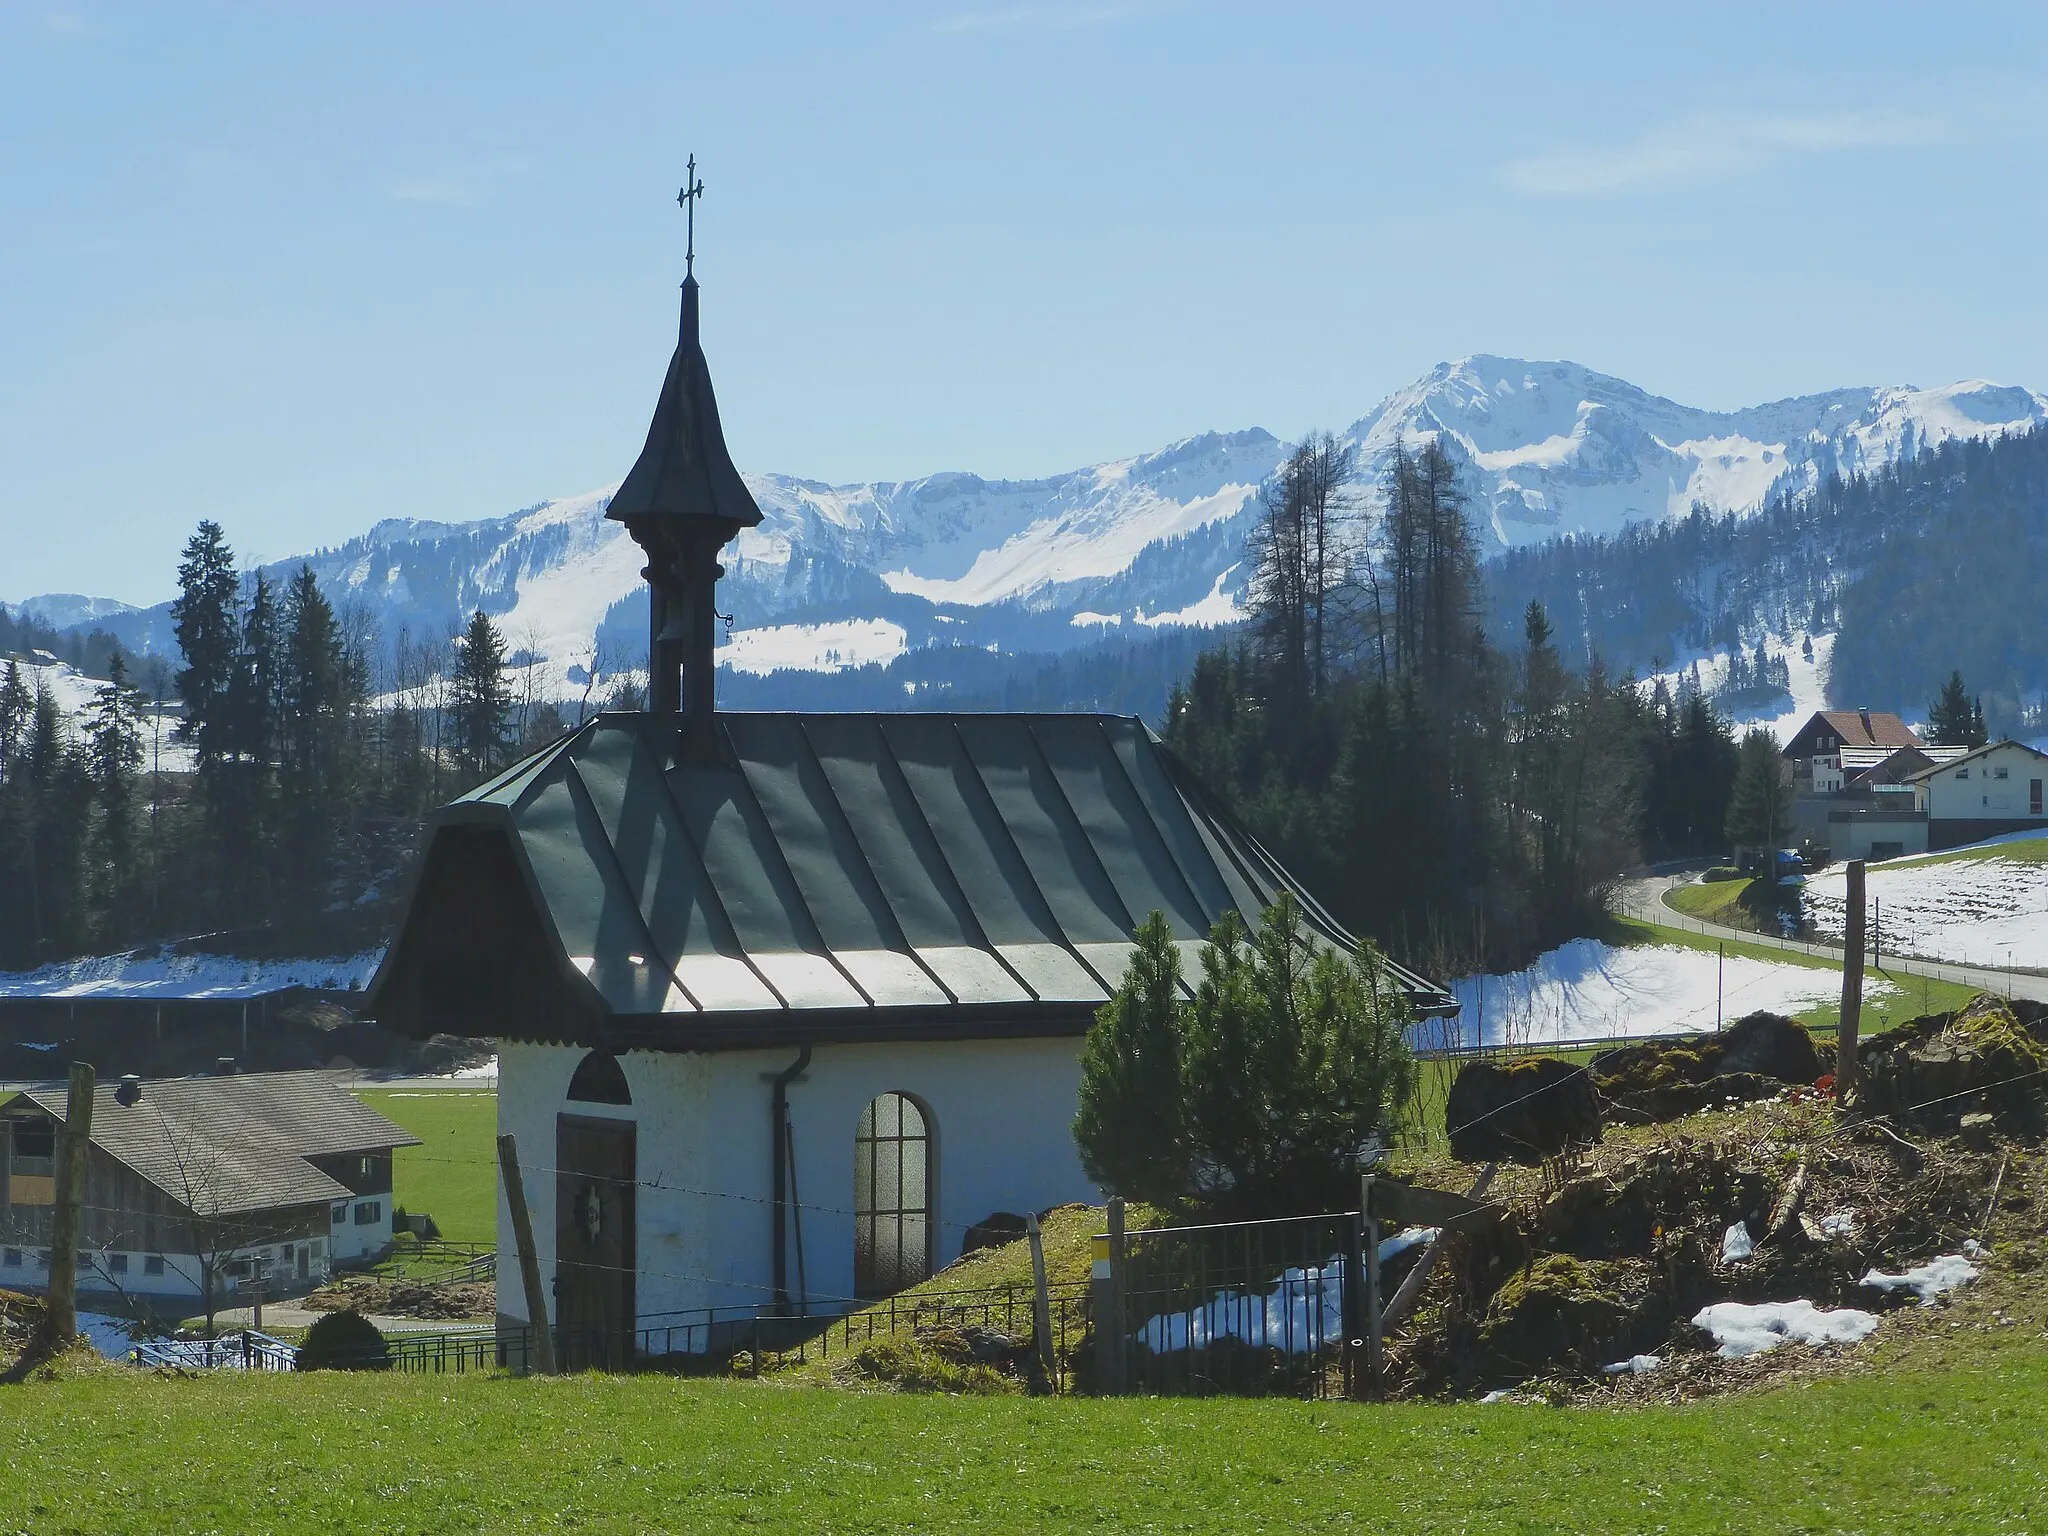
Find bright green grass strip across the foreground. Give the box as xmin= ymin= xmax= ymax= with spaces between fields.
xmin=12 ymin=1341 xmax=2048 ymax=1536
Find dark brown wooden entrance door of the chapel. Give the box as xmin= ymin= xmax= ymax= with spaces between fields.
xmin=555 ymin=1114 xmax=635 ymax=1370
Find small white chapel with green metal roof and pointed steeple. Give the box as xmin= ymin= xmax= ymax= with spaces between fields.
xmin=369 ymin=237 xmax=1456 ymax=1341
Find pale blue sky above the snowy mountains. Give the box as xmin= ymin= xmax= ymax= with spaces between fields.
xmin=0 ymin=0 xmax=2048 ymax=602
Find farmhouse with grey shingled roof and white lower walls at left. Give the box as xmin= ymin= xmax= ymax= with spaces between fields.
xmin=0 ymin=1071 xmax=420 ymax=1303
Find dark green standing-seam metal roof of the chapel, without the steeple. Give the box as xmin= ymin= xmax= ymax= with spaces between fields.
xmin=371 ymin=713 xmax=1456 ymax=1049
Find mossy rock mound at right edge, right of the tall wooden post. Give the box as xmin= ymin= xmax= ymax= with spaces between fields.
xmin=1855 ymin=993 xmax=2048 ymax=1135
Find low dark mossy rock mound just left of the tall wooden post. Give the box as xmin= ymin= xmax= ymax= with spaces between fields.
xmin=1591 ymin=1012 xmax=1825 ymax=1120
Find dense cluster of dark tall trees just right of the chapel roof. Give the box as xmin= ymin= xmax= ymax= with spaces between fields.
xmin=1167 ymin=436 xmax=1736 ymax=975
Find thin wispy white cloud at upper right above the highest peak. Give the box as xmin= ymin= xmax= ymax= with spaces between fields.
xmin=1501 ymin=109 xmax=1954 ymax=197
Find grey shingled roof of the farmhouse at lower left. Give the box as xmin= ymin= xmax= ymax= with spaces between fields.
xmin=3 ymin=1071 xmax=420 ymax=1217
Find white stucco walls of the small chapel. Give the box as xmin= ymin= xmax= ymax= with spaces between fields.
xmin=498 ymin=1040 xmax=1098 ymax=1319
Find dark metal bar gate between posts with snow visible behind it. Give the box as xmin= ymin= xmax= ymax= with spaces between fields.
xmin=1102 ymin=1212 xmax=1364 ymax=1397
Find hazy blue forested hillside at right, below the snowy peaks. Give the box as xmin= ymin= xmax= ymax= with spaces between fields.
xmin=1487 ymin=430 xmax=2048 ymax=733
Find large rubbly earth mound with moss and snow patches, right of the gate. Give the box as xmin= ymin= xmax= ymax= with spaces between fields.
xmin=1389 ymin=1102 xmax=1990 ymax=1397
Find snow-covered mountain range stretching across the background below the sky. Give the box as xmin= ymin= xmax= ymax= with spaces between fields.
xmin=28 ymin=356 xmax=2048 ymax=694
